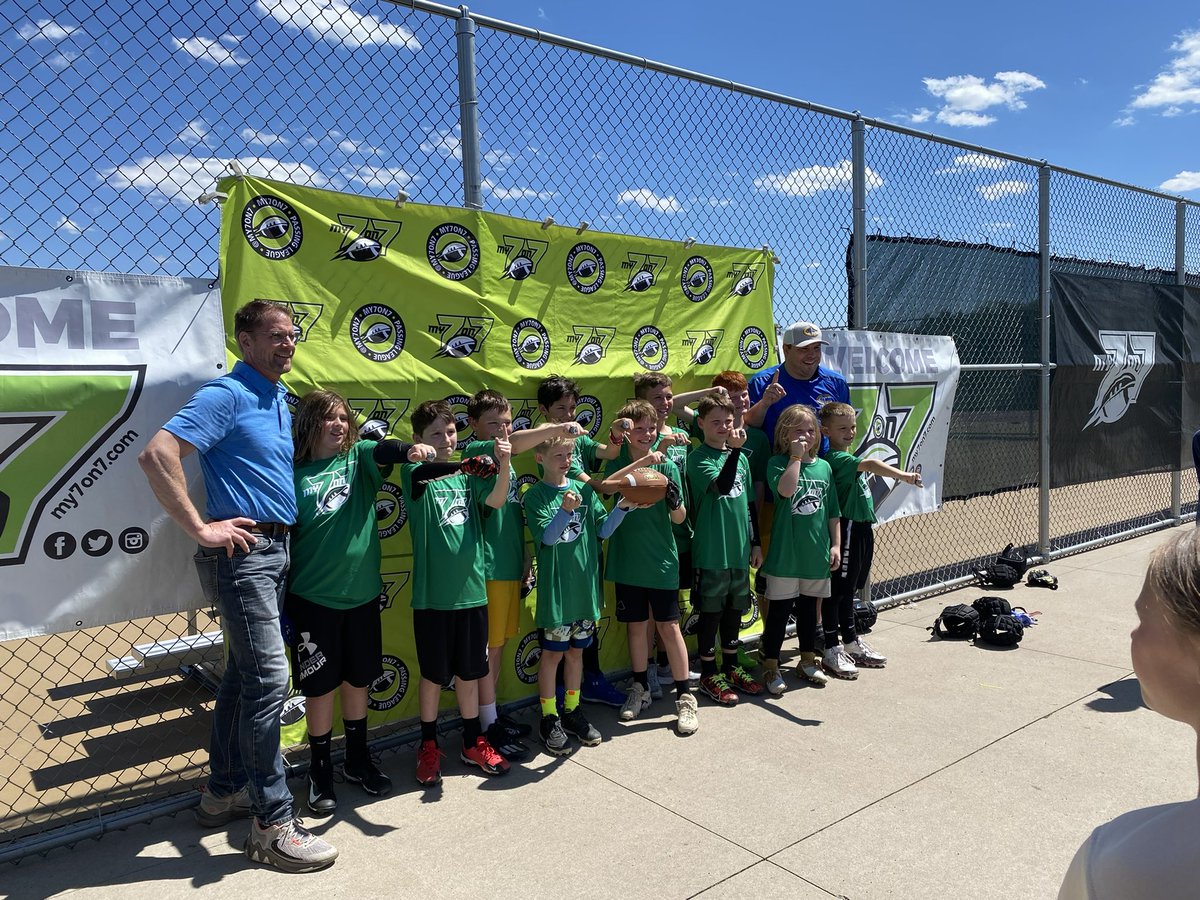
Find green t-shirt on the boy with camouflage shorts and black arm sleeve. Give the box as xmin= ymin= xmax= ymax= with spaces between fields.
xmin=688 ymin=444 xmax=750 ymax=569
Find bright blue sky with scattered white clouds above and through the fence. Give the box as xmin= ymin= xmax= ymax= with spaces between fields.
xmin=0 ymin=0 xmax=1200 ymax=312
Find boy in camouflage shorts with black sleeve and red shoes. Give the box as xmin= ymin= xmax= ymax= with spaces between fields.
xmin=686 ymin=396 xmax=762 ymax=706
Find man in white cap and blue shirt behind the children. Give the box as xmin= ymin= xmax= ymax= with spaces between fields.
xmin=746 ymin=322 xmax=850 ymax=449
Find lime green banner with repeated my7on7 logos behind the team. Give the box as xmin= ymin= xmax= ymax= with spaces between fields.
xmin=220 ymin=176 xmax=775 ymax=739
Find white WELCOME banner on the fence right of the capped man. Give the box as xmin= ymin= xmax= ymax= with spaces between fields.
xmin=822 ymin=329 xmax=959 ymax=522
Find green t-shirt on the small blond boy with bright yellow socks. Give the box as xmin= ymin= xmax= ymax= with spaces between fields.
xmin=524 ymin=479 xmax=609 ymax=628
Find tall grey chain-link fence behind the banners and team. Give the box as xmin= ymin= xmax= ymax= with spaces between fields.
xmin=0 ymin=0 xmax=1200 ymax=859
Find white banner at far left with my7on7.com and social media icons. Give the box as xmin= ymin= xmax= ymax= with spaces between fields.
xmin=0 ymin=266 xmax=226 ymax=641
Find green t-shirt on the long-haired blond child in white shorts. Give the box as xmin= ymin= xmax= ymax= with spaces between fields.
xmin=762 ymin=455 xmax=841 ymax=580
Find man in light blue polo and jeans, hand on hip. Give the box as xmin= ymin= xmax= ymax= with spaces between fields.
xmin=138 ymin=300 xmax=337 ymax=872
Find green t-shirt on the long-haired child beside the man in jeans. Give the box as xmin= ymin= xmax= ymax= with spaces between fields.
xmin=288 ymin=440 xmax=383 ymax=610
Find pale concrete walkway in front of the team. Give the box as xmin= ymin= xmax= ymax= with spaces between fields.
xmin=0 ymin=526 xmax=1196 ymax=900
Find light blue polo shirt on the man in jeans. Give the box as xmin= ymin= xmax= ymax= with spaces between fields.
xmin=162 ymin=361 xmax=296 ymax=524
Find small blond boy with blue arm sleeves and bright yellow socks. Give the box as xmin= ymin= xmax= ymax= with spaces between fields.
xmin=524 ymin=437 xmax=631 ymax=756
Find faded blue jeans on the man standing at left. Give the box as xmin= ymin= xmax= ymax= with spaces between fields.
xmin=193 ymin=535 xmax=293 ymax=826
